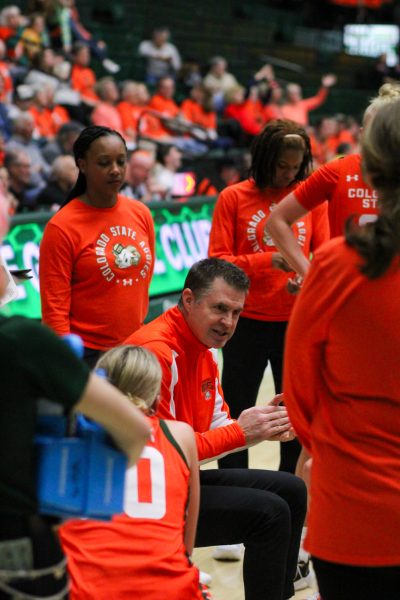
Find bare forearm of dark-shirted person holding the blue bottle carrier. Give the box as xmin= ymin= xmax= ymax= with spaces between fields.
xmin=75 ymin=374 xmax=150 ymax=465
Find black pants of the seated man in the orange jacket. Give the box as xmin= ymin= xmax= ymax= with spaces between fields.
xmin=195 ymin=469 xmax=307 ymax=600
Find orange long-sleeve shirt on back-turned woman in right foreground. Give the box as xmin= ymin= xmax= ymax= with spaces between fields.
xmin=284 ymin=238 xmax=400 ymax=566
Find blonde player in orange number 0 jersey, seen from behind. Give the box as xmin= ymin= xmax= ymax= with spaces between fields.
xmin=60 ymin=346 xmax=209 ymax=600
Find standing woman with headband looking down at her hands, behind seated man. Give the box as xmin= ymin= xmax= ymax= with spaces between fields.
xmin=209 ymin=120 xmax=329 ymax=473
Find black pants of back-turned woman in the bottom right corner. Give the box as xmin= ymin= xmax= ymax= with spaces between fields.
xmin=312 ymin=556 xmax=400 ymax=600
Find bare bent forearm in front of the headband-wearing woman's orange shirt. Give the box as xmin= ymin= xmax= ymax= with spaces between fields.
xmin=265 ymin=192 xmax=310 ymax=277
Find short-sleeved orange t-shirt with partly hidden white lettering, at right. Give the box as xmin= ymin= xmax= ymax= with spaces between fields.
xmin=294 ymin=154 xmax=378 ymax=237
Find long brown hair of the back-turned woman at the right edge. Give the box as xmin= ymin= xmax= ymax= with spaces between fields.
xmin=346 ymin=100 xmax=400 ymax=279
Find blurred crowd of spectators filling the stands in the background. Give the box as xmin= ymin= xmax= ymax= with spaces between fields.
xmin=0 ymin=0 xmax=366 ymax=214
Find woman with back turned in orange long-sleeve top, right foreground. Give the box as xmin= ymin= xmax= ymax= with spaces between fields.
xmin=284 ymin=95 xmax=400 ymax=600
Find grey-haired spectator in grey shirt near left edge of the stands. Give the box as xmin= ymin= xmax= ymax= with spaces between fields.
xmin=7 ymin=112 xmax=50 ymax=187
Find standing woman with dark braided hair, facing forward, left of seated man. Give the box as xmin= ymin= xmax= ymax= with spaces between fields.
xmin=40 ymin=126 xmax=155 ymax=366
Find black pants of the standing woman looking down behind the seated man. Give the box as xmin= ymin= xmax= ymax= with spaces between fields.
xmin=218 ymin=317 xmax=300 ymax=473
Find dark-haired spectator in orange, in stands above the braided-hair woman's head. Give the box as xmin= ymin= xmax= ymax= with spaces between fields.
xmin=71 ymin=42 xmax=99 ymax=107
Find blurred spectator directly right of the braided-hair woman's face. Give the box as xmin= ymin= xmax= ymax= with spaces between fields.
xmin=121 ymin=150 xmax=160 ymax=203
